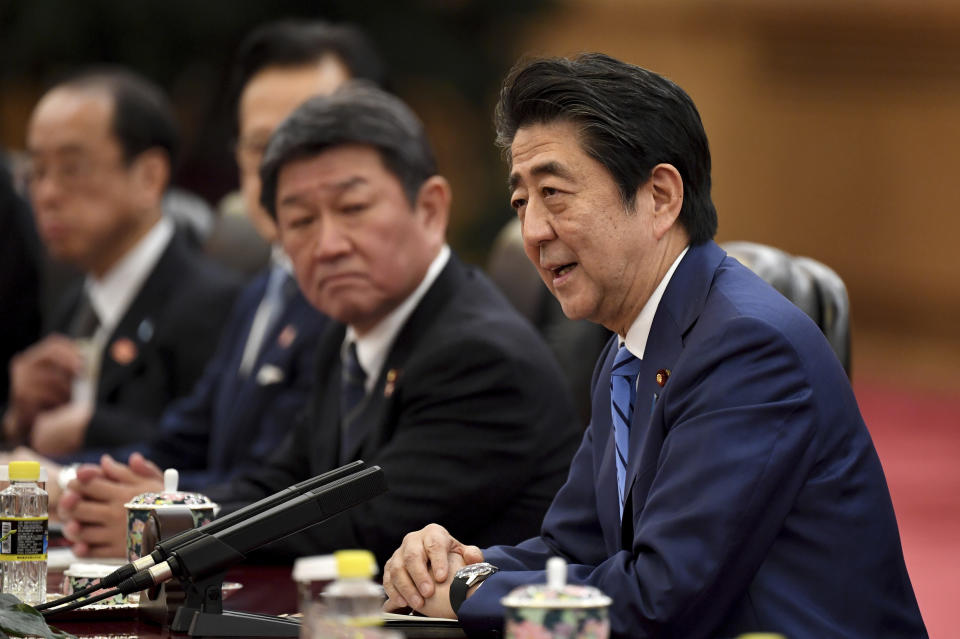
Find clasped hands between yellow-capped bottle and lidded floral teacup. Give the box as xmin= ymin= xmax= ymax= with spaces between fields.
xmin=59 ymin=453 xmax=163 ymax=557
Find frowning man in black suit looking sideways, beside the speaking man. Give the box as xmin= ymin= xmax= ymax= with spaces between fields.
xmin=195 ymin=86 xmax=580 ymax=561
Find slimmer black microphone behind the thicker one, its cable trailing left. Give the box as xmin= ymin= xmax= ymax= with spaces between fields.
xmin=36 ymin=460 xmax=365 ymax=610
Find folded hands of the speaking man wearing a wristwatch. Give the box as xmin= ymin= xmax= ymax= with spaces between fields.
xmin=383 ymin=524 xmax=483 ymax=619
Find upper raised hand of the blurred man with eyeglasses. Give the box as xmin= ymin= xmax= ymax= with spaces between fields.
xmin=3 ymin=335 xmax=84 ymax=441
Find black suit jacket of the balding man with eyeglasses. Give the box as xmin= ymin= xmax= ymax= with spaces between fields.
xmin=52 ymin=234 xmax=239 ymax=447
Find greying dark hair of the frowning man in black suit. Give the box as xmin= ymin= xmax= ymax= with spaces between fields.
xmin=260 ymin=82 xmax=437 ymax=217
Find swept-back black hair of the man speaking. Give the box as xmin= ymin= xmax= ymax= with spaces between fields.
xmin=495 ymin=53 xmax=717 ymax=244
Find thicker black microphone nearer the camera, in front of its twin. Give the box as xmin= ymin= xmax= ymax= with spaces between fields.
xmin=118 ymin=466 xmax=387 ymax=595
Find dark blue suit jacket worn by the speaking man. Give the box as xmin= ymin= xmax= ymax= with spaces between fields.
xmin=460 ymin=242 xmax=926 ymax=639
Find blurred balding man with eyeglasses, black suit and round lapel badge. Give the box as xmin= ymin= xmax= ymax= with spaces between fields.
xmin=3 ymin=69 xmax=237 ymax=455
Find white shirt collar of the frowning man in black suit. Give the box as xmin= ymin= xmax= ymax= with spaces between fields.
xmin=341 ymin=244 xmax=450 ymax=392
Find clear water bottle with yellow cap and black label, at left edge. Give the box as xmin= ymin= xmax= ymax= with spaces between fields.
xmin=0 ymin=461 xmax=47 ymax=605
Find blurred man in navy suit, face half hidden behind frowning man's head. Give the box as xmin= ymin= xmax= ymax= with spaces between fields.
xmin=51 ymin=21 xmax=383 ymax=556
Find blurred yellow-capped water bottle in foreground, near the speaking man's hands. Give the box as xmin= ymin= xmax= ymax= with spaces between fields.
xmin=323 ymin=550 xmax=385 ymax=627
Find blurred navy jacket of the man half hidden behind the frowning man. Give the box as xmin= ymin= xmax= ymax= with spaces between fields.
xmin=88 ymin=269 xmax=328 ymax=490
